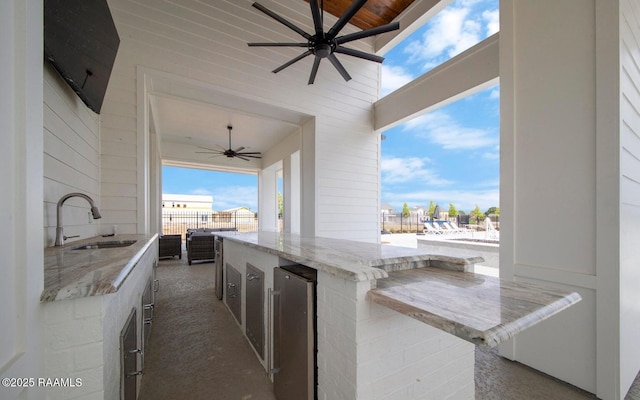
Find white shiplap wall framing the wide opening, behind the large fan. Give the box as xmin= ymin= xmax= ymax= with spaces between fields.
xmin=102 ymin=0 xmax=380 ymax=241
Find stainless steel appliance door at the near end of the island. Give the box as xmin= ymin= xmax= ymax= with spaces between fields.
xmin=273 ymin=268 xmax=315 ymax=400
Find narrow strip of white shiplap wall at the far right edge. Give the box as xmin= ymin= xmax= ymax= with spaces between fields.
xmin=620 ymin=0 xmax=640 ymax=395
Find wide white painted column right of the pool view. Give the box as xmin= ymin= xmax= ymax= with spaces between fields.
xmin=500 ymin=0 xmax=624 ymax=399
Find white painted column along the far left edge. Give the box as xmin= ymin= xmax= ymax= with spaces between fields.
xmin=0 ymin=0 xmax=44 ymax=399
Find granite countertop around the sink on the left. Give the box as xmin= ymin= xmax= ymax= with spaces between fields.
xmin=40 ymin=234 xmax=158 ymax=302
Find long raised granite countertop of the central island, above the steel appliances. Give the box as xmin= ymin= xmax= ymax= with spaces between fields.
xmin=213 ymin=232 xmax=483 ymax=281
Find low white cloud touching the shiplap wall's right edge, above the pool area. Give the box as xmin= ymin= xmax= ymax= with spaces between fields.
xmin=381 ymin=157 xmax=451 ymax=185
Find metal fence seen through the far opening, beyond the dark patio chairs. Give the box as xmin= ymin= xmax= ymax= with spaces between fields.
xmin=162 ymin=211 xmax=258 ymax=239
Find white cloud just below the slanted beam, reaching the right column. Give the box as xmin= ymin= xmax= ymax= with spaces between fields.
xmin=403 ymin=110 xmax=497 ymax=150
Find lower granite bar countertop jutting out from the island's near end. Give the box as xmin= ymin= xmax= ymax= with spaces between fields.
xmin=367 ymin=267 xmax=581 ymax=347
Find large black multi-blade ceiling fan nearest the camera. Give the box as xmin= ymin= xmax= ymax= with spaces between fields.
xmin=247 ymin=0 xmax=400 ymax=85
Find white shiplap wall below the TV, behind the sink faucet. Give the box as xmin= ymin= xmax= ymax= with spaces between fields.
xmin=43 ymin=64 xmax=102 ymax=246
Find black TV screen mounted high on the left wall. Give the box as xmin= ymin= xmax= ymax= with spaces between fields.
xmin=44 ymin=0 xmax=120 ymax=114
